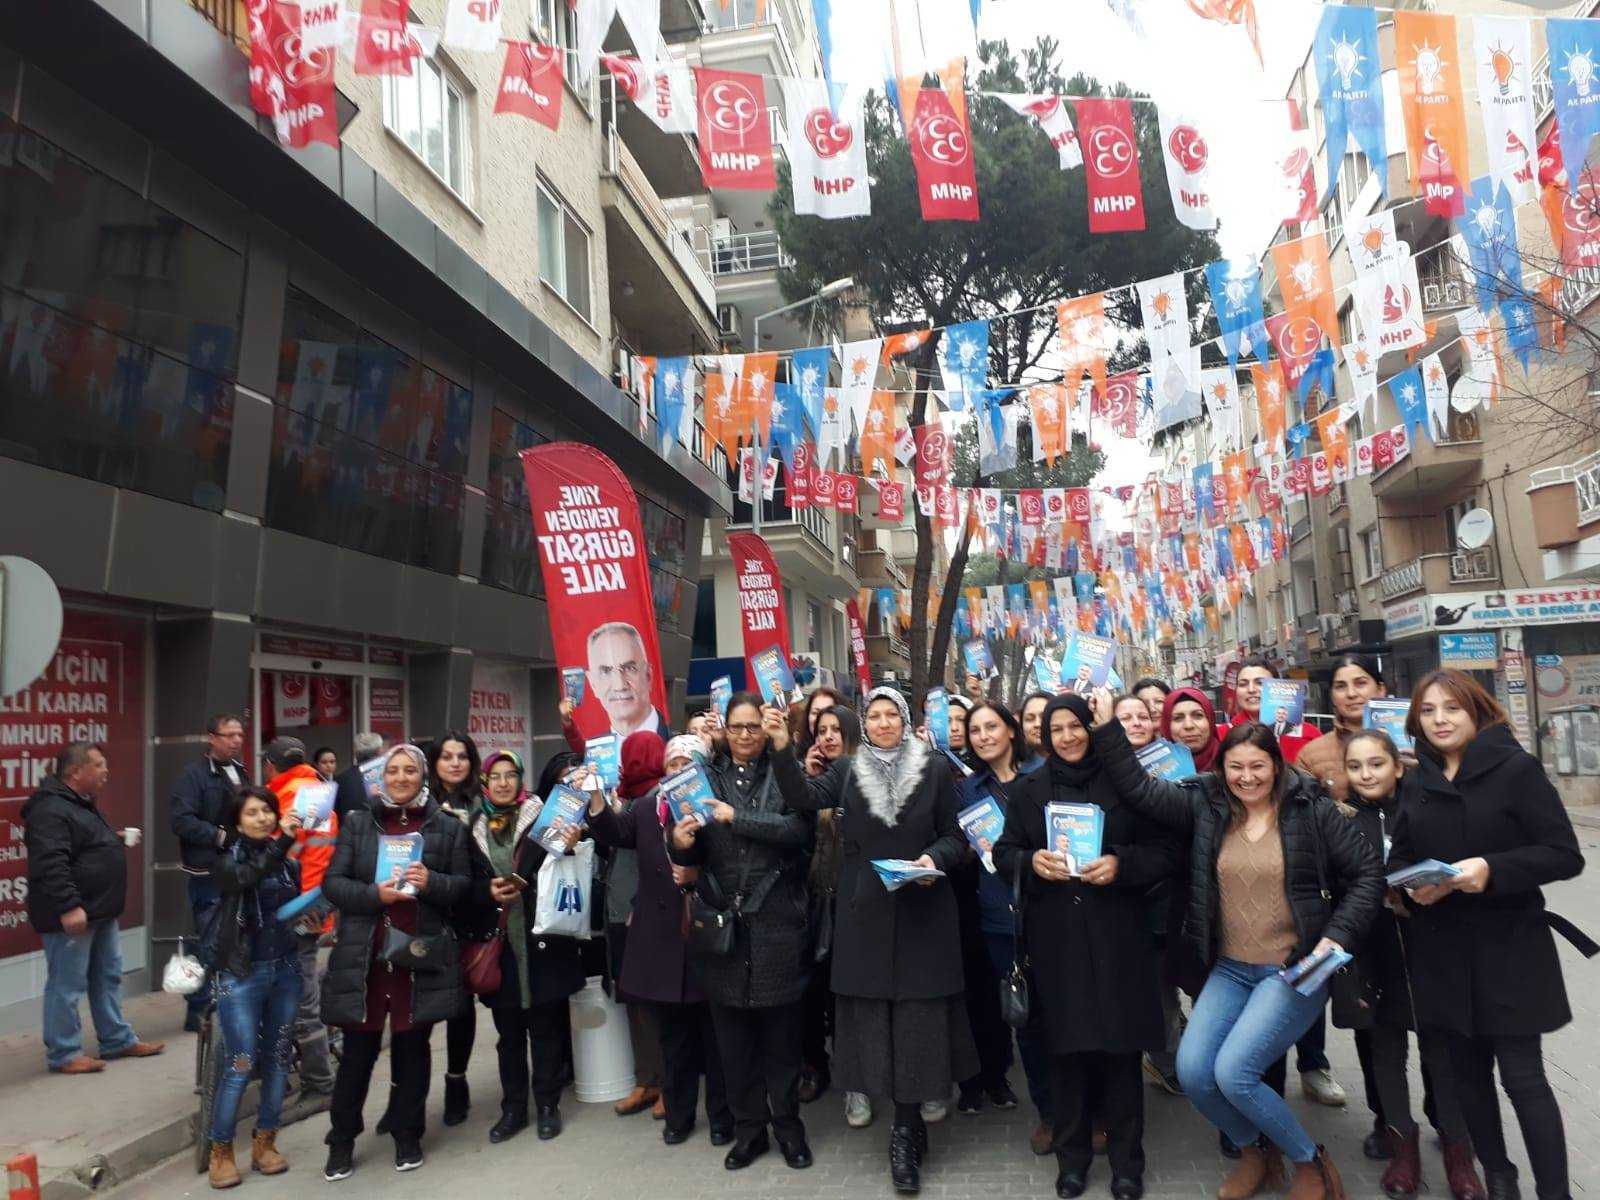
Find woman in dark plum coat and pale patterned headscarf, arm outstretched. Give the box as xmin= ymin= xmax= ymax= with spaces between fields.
xmin=589 ymin=733 xmax=733 ymax=1146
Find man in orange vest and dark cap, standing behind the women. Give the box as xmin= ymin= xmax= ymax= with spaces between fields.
xmin=262 ymin=738 xmax=339 ymax=1120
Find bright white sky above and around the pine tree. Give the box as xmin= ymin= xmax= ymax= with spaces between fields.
xmin=830 ymin=0 xmax=1320 ymax=502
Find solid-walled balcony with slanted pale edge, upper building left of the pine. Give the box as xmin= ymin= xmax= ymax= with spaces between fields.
xmin=600 ymin=125 xmax=718 ymax=354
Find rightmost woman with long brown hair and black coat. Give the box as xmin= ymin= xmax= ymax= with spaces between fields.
xmin=1389 ymin=670 xmax=1595 ymax=1200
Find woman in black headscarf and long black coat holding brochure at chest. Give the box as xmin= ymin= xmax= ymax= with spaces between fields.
xmin=995 ymin=693 xmax=1181 ymax=1200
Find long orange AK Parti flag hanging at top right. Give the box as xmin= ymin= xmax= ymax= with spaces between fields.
xmin=1394 ymin=10 xmax=1472 ymax=216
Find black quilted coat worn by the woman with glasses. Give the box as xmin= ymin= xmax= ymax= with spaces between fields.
xmin=670 ymin=755 xmax=811 ymax=1008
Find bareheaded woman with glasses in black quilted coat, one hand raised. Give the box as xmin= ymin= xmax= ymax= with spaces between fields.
xmin=662 ymin=693 xmax=811 ymax=1171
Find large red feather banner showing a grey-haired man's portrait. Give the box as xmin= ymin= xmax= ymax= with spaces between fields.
xmin=522 ymin=442 xmax=667 ymax=738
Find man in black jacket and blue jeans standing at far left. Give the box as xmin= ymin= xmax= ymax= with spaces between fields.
xmin=22 ymin=742 xmax=163 ymax=1075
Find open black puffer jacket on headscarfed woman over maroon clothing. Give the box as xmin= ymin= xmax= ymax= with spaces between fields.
xmin=322 ymin=800 xmax=490 ymax=1026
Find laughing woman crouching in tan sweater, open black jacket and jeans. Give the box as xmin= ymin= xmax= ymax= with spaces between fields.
xmin=1091 ymin=690 xmax=1382 ymax=1200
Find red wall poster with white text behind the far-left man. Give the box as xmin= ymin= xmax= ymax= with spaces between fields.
xmin=0 ymin=610 xmax=150 ymax=958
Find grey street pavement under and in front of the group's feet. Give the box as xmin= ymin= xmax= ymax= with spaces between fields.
xmin=112 ymin=826 xmax=1600 ymax=1200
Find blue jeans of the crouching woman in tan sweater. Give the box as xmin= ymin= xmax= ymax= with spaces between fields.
xmin=1178 ymin=958 xmax=1328 ymax=1163
